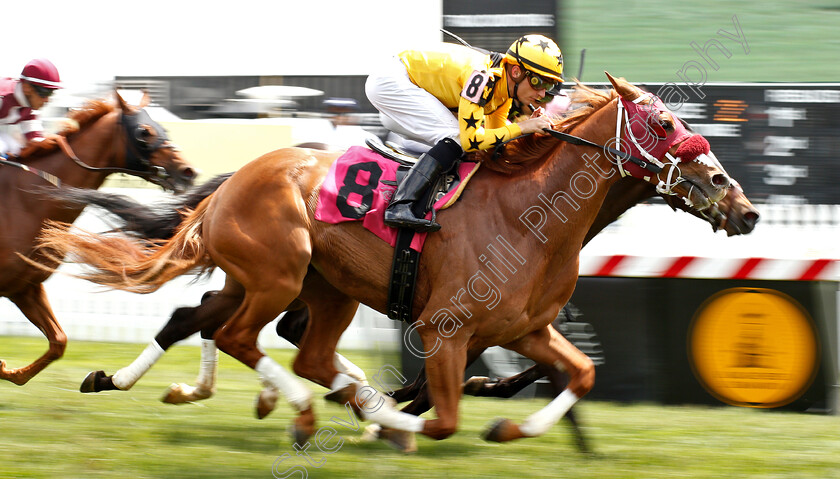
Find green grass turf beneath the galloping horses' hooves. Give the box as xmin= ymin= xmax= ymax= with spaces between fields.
xmin=0 ymin=337 xmax=840 ymax=478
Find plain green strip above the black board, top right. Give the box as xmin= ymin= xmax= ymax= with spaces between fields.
xmin=560 ymin=0 xmax=840 ymax=84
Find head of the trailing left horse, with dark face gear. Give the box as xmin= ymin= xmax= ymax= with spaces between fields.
xmin=116 ymin=91 xmax=197 ymax=192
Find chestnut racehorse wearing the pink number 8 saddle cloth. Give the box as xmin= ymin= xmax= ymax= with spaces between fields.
xmin=34 ymin=73 xmax=729 ymax=444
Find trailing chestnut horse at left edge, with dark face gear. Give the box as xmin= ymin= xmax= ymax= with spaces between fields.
xmin=0 ymin=94 xmax=195 ymax=385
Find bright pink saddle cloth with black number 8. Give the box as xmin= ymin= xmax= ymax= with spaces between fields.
xmin=315 ymin=146 xmax=479 ymax=251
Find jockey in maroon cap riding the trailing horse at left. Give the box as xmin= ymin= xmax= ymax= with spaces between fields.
xmin=0 ymin=59 xmax=61 ymax=157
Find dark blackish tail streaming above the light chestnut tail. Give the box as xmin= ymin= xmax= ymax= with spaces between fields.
xmin=44 ymin=173 xmax=233 ymax=240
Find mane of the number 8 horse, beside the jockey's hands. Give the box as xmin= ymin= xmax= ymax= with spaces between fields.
xmin=480 ymin=82 xmax=618 ymax=174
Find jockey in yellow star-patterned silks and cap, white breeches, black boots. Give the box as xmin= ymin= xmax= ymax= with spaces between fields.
xmin=365 ymin=35 xmax=563 ymax=231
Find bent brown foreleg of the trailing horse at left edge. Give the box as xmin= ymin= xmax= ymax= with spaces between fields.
xmin=0 ymin=283 xmax=67 ymax=386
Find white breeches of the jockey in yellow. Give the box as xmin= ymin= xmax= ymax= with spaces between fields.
xmin=365 ymin=58 xmax=461 ymax=147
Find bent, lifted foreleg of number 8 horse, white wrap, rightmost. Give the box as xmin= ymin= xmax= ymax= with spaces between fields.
xmin=484 ymin=326 xmax=595 ymax=442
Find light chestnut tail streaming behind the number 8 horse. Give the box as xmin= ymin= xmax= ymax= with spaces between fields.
xmin=38 ymin=199 xmax=215 ymax=293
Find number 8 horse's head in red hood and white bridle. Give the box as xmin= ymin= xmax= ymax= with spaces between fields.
xmin=605 ymin=72 xmax=730 ymax=211
